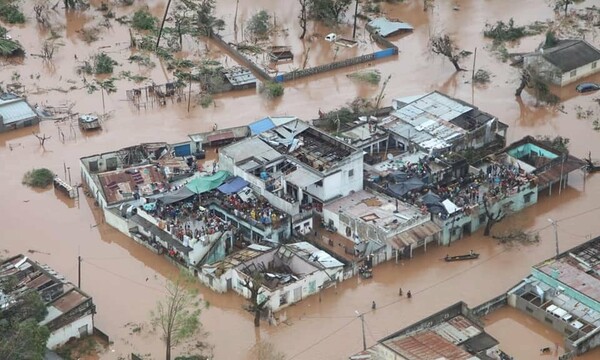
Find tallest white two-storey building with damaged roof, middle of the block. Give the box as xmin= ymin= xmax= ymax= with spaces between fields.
xmin=219 ymin=120 xmax=363 ymax=216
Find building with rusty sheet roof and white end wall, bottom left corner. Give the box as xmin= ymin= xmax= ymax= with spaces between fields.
xmin=0 ymin=255 xmax=96 ymax=349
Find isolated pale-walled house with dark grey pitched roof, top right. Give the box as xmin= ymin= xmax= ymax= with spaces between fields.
xmin=523 ymin=40 xmax=600 ymax=86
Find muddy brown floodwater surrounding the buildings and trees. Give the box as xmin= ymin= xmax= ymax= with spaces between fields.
xmin=0 ymin=0 xmax=600 ymax=360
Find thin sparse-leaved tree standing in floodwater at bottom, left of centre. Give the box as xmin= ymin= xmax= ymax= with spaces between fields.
xmin=150 ymin=274 xmax=202 ymax=360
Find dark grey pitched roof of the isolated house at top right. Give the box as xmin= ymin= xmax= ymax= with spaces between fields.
xmin=542 ymin=40 xmax=600 ymax=72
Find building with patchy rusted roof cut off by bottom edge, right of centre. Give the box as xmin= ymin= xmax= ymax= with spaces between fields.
xmin=349 ymin=302 xmax=510 ymax=360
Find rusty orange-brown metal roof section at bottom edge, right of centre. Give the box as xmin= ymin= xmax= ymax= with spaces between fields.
xmin=385 ymin=330 xmax=477 ymax=360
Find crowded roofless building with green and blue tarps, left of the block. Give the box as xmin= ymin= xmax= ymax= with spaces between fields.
xmin=81 ymin=142 xmax=291 ymax=267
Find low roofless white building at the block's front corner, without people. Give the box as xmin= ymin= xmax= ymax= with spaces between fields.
xmin=198 ymin=242 xmax=344 ymax=312
